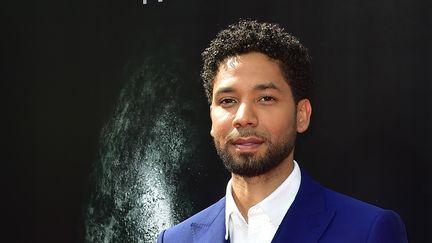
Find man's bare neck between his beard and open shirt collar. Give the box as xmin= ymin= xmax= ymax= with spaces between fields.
xmin=231 ymin=153 xmax=294 ymax=222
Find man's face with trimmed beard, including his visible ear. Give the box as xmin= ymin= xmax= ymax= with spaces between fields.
xmin=210 ymin=52 xmax=310 ymax=177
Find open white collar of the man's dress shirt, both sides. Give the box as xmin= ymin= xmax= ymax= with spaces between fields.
xmin=225 ymin=160 xmax=301 ymax=240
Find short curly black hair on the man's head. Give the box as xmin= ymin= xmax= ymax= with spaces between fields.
xmin=201 ymin=20 xmax=313 ymax=104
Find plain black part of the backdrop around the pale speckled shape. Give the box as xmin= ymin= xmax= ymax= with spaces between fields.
xmin=5 ymin=0 xmax=432 ymax=242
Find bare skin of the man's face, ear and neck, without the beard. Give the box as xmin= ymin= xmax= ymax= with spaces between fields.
xmin=210 ymin=52 xmax=312 ymax=221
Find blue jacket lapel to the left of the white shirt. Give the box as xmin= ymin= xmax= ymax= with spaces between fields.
xmin=191 ymin=197 xmax=226 ymax=243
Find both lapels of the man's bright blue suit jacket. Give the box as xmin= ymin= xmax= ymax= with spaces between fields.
xmin=191 ymin=171 xmax=334 ymax=243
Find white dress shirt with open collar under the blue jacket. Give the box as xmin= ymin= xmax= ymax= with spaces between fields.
xmin=225 ymin=161 xmax=301 ymax=243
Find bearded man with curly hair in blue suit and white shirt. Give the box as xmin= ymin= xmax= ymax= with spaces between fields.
xmin=158 ymin=21 xmax=407 ymax=243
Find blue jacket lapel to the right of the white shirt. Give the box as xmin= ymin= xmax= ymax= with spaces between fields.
xmin=272 ymin=173 xmax=334 ymax=243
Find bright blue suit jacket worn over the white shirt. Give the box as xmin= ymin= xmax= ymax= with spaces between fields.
xmin=158 ymin=172 xmax=408 ymax=243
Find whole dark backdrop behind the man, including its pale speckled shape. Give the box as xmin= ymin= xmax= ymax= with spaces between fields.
xmin=5 ymin=0 xmax=432 ymax=242
